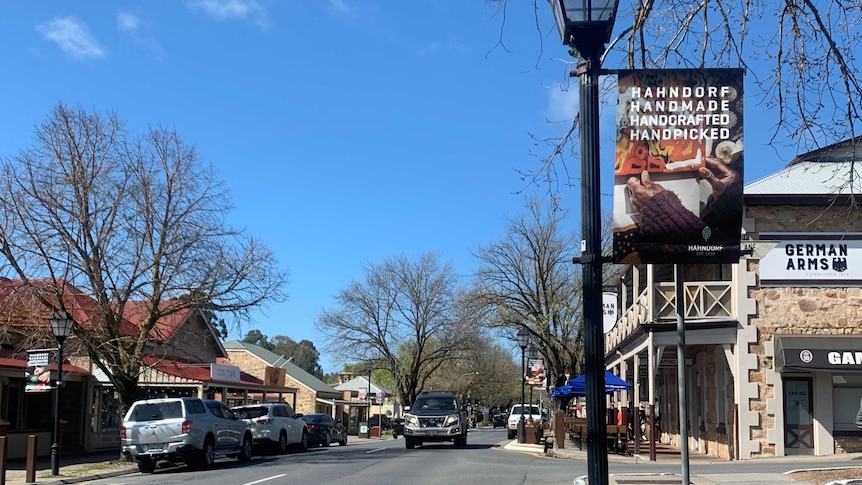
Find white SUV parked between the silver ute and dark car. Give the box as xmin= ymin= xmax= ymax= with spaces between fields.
xmin=231 ymin=403 xmax=308 ymax=454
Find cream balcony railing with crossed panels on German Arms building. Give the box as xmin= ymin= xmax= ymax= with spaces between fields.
xmin=605 ymin=281 xmax=736 ymax=349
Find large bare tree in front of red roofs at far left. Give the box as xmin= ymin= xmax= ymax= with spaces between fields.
xmin=0 ymin=104 xmax=287 ymax=409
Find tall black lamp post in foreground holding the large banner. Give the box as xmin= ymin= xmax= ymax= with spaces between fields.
xmin=548 ymin=0 xmax=619 ymax=485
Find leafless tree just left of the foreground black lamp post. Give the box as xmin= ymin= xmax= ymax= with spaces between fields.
xmin=471 ymin=195 xmax=618 ymax=396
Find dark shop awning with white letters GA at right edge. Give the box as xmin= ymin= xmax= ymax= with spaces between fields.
xmin=775 ymin=335 xmax=862 ymax=372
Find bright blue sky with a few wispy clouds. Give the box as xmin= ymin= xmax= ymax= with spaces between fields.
xmin=0 ymin=0 xmax=795 ymax=372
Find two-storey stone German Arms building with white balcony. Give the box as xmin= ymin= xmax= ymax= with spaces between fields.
xmin=605 ymin=139 xmax=862 ymax=459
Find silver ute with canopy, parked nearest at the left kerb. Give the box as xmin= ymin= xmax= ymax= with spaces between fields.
xmin=120 ymin=397 xmax=253 ymax=473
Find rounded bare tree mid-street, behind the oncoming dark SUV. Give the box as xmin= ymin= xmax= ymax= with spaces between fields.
xmin=315 ymin=253 xmax=473 ymax=403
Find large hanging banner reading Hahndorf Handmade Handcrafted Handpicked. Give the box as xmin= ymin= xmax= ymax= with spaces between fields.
xmin=613 ymin=69 xmax=743 ymax=264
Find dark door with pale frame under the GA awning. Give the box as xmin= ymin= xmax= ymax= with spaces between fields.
xmin=784 ymin=377 xmax=814 ymax=454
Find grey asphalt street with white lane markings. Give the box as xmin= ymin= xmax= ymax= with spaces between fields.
xmin=76 ymin=429 xmax=862 ymax=485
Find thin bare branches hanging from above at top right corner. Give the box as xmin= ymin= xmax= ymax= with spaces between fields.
xmin=485 ymin=0 xmax=862 ymax=193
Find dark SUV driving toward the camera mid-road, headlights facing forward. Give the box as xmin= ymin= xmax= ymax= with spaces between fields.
xmin=404 ymin=392 xmax=467 ymax=450
